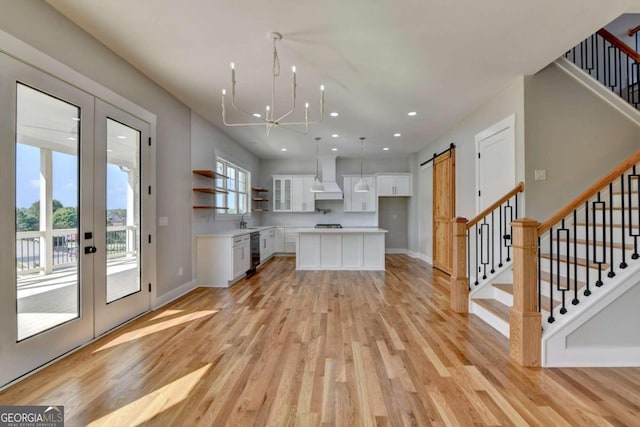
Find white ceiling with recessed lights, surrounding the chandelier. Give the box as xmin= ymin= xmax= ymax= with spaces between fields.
xmin=47 ymin=0 xmax=638 ymax=158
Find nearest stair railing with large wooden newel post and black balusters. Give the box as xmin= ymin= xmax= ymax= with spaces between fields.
xmin=509 ymin=151 xmax=640 ymax=366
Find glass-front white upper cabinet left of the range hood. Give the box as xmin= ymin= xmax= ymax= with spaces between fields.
xmin=273 ymin=175 xmax=316 ymax=212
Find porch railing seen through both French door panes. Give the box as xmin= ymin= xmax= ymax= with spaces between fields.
xmin=16 ymin=226 xmax=137 ymax=274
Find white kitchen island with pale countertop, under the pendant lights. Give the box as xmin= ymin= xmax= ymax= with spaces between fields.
xmin=296 ymin=227 xmax=387 ymax=271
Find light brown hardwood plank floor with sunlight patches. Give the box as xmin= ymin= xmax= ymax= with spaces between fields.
xmin=0 ymin=255 xmax=640 ymax=426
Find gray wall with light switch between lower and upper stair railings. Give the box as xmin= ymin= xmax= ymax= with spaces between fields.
xmin=524 ymin=64 xmax=640 ymax=222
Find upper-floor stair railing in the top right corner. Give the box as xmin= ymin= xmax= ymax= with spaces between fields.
xmin=565 ymin=27 xmax=640 ymax=109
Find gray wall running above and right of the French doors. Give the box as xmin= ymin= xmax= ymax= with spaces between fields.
xmin=0 ymin=0 xmax=192 ymax=296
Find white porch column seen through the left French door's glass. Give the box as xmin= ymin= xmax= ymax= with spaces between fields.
xmin=40 ymin=148 xmax=53 ymax=274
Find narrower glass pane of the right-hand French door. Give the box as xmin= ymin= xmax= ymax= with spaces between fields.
xmin=105 ymin=119 xmax=141 ymax=303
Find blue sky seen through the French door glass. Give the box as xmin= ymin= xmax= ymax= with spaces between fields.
xmin=16 ymin=144 xmax=127 ymax=209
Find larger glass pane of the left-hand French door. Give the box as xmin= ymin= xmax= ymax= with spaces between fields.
xmin=15 ymin=83 xmax=80 ymax=341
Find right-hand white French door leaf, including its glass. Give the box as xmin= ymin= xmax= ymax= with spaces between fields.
xmin=94 ymin=99 xmax=151 ymax=336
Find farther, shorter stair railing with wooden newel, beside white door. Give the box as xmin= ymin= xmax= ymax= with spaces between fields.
xmin=450 ymin=182 xmax=524 ymax=313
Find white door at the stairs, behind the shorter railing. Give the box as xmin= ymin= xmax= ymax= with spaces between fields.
xmin=476 ymin=115 xmax=516 ymax=213
